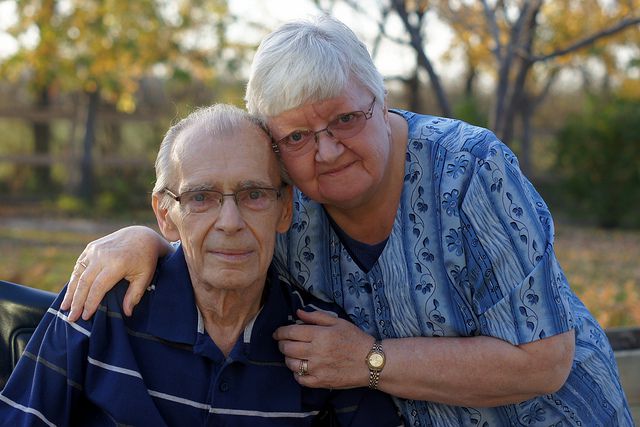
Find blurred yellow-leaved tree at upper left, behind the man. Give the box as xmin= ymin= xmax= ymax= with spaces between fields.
xmin=0 ymin=0 xmax=233 ymax=199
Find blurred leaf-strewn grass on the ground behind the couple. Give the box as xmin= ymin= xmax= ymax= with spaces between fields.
xmin=0 ymin=218 xmax=640 ymax=327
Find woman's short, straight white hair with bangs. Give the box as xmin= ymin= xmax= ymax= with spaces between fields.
xmin=245 ymin=15 xmax=385 ymax=118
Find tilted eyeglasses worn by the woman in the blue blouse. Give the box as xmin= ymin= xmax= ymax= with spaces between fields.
xmin=273 ymin=96 xmax=376 ymax=156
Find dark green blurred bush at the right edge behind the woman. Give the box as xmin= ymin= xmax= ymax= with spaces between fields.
xmin=557 ymin=96 xmax=640 ymax=228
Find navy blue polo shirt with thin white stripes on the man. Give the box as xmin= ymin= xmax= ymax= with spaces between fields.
xmin=0 ymin=248 xmax=401 ymax=427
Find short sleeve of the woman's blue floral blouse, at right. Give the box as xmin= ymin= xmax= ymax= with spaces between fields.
xmin=460 ymin=139 xmax=573 ymax=345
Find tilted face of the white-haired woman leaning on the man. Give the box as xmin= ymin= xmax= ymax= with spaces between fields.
xmin=268 ymin=82 xmax=391 ymax=209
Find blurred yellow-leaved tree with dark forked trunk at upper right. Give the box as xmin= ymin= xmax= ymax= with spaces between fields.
xmin=438 ymin=0 xmax=640 ymax=171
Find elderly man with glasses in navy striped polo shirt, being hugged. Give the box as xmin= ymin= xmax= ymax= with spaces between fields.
xmin=0 ymin=105 xmax=400 ymax=426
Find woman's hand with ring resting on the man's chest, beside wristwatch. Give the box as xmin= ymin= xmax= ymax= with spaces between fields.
xmin=273 ymin=310 xmax=375 ymax=388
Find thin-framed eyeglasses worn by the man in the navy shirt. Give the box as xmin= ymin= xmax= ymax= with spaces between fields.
xmin=164 ymin=187 xmax=282 ymax=214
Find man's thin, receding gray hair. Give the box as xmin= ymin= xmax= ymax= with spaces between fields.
xmin=153 ymin=104 xmax=291 ymax=208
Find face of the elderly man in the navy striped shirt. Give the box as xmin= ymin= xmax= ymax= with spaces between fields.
xmin=154 ymin=124 xmax=291 ymax=291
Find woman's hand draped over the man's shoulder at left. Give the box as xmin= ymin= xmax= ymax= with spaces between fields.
xmin=60 ymin=226 xmax=172 ymax=322
